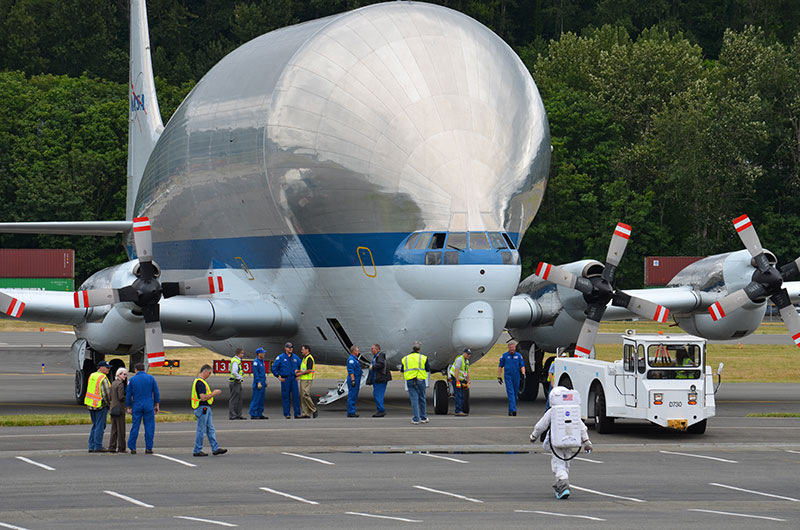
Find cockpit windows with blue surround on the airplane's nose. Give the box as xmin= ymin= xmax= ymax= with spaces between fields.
xmin=395 ymin=231 xmax=520 ymax=265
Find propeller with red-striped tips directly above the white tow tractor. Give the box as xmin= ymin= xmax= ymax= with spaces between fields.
xmin=536 ymin=223 xmax=669 ymax=357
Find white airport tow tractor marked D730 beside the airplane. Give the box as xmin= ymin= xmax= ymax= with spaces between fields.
xmin=554 ymin=330 xmax=723 ymax=434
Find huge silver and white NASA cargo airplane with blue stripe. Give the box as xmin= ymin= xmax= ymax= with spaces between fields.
xmin=0 ymin=0 xmax=800 ymax=400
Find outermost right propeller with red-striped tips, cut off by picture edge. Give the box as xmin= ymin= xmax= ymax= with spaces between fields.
xmin=708 ymin=215 xmax=800 ymax=347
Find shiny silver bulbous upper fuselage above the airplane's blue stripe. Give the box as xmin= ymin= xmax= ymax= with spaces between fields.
xmin=135 ymin=2 xmax=550 ymax=266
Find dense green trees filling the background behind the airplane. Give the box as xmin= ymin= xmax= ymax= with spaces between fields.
xmin=0 ymin=0 xmax=800 ymax=287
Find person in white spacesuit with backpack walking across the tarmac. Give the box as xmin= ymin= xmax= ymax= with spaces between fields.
xmin=530 ymin=386 xmax=592 ymax=499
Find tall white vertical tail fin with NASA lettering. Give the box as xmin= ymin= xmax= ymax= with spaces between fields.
xmin=125 ymin=0 xmax=164 ymax=220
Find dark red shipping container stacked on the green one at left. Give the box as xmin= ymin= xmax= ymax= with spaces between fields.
xmin=0 ymin=248 xmax=75 ymax=278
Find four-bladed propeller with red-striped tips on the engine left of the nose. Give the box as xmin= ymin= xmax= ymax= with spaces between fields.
xmin=74 ymin=217 xmax=223 ymax=366
